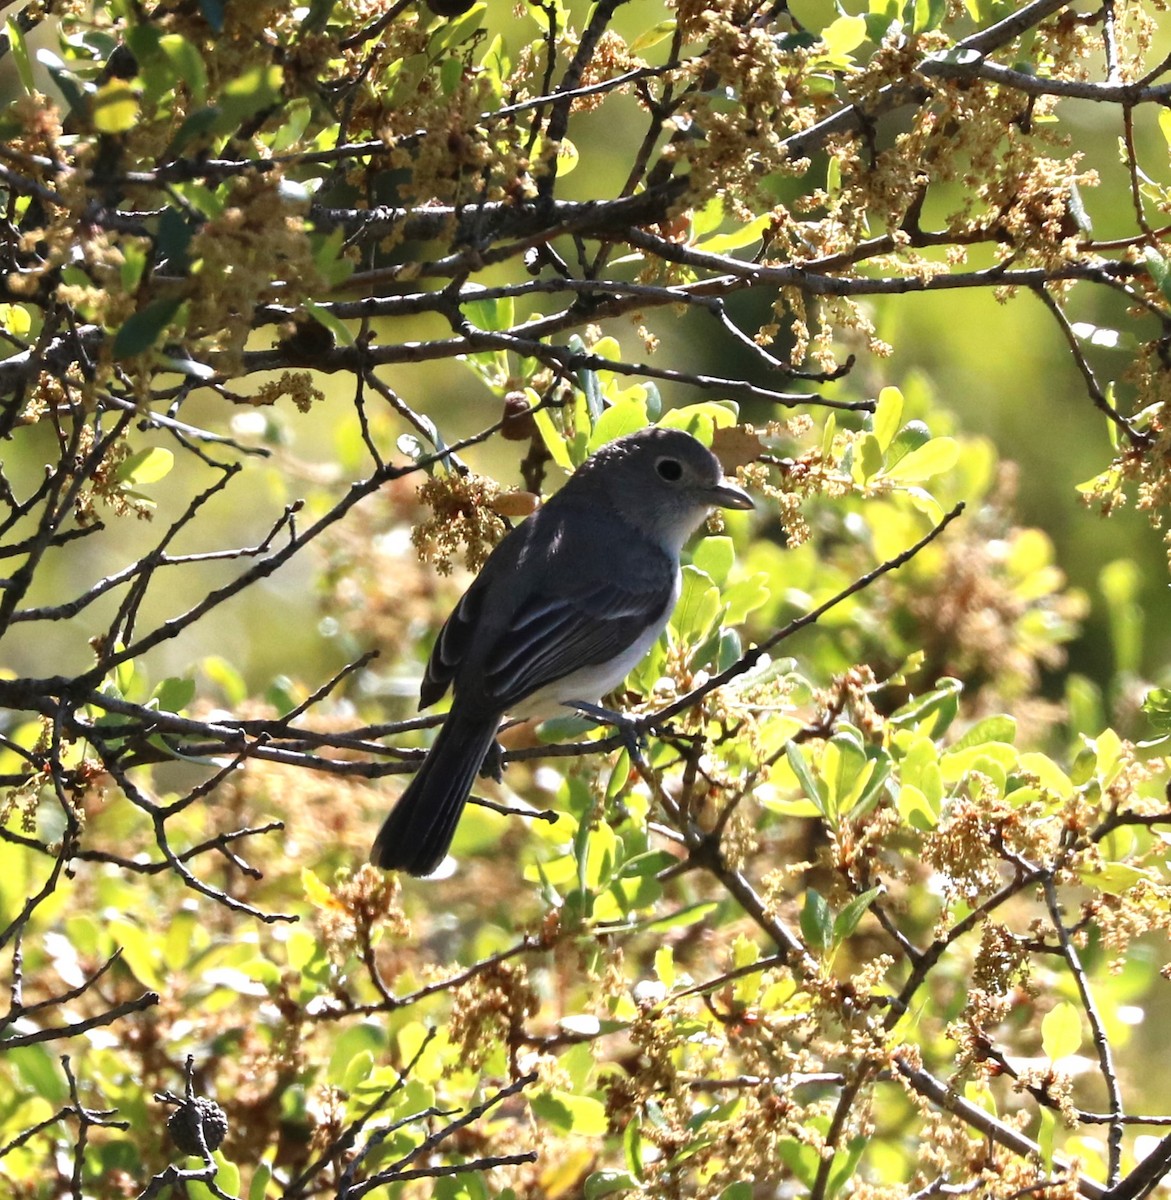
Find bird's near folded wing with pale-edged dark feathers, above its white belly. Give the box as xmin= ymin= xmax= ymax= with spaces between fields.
xmin=484 ymin=570 xmax=674 ymax=709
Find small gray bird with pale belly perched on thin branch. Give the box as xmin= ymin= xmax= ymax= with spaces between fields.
xmin=371 ymin=427 xmax=753 ymax=875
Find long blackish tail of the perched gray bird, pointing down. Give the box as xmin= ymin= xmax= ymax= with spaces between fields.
xmin=370 ymin=709 xmax=499 ymax=875
